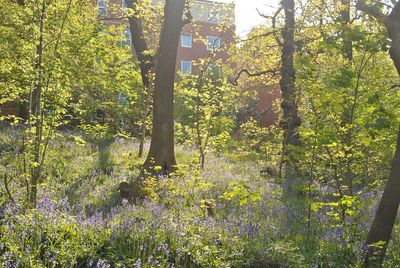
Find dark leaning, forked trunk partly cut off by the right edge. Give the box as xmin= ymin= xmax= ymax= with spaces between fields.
xmin=357 ymin=0 xmax=400 ymax=267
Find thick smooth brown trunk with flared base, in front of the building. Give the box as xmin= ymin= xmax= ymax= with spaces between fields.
xmin=144 ymin=0 xmax=185 ymax=174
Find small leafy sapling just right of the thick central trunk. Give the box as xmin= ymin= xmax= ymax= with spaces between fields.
xmin=177 ymin=61 xmax=238 ymax=169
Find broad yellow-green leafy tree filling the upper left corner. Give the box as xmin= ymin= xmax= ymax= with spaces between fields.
xmin=0 ymin=0 xmax=139 ymax=207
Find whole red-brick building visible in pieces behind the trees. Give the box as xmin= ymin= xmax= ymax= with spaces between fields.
xmin=0 ymin=0 xmax=280 ymax=125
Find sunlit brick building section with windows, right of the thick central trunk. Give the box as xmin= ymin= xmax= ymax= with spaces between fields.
xmin=176 ymin=0 xmax=235 ymax=74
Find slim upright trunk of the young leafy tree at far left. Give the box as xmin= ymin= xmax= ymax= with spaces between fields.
xmin=29 ymin=0 xmax=47 ymax=208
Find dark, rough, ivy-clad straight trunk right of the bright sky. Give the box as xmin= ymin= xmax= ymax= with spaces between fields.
xmin=280 ymin=0 xmax=301 ymax=225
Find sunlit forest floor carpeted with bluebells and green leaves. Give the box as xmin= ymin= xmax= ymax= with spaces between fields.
xmin=0 ymin=129 xmax=400 ymax=267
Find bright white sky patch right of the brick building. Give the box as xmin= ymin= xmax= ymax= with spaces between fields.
xmin=218 ymin=0 xmax=278 ymax=36
